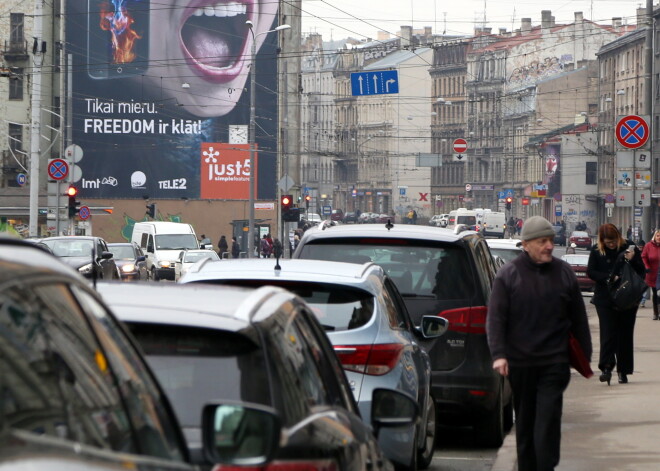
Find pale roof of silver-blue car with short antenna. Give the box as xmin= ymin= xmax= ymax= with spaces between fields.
xmin=182 ymin=259 xmax=385 ymax=291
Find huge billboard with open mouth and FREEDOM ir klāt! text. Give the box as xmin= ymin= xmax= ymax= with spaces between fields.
xmin=63 ymin=0 xmax=278 ymax=199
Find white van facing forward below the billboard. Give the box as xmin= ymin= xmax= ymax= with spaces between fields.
xmin=131 ymin=221 xmax=199 ymax=281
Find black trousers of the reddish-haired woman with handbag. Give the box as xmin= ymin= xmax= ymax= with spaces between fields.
xmin=596 ymin=306 xmax=637 ymax=375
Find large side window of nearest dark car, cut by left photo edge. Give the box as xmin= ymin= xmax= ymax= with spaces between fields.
xmin=0 ymin=283 xmax=138 ymax=453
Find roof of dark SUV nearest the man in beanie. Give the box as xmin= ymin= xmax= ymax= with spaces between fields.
xmin=302 ymin=224 xmax=476 ymax=243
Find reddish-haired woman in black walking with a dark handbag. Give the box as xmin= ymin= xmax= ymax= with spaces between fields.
xmin=587 ymin=224 xmax=646 ymax=385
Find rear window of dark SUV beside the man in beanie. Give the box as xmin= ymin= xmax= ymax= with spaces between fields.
xmin=300 ymin=242 xmax=475 ymax=300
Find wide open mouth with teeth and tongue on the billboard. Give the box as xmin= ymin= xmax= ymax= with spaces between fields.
xmin=181 ymin=2 xmax=249 ymax=75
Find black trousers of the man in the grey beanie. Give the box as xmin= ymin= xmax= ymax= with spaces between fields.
xmin=509 ymin=363 xmax=571 ymax=471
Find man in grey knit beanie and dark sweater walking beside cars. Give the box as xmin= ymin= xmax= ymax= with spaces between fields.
xmin=486 ymin=216 xmax=592 ymax=471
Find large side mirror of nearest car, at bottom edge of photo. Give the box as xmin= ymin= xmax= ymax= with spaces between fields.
xmin=202 ymin=401 xmax=282 ymax=466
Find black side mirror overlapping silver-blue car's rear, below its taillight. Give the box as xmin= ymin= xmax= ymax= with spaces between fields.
xmin=371 ymin=388 xmax=419 ymax=438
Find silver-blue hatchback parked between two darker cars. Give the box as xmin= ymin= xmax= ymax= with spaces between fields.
xmin=181 ymin=259 xmax=447 ymax=470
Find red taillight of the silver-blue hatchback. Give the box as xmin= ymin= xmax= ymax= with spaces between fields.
xmin=334 ymin=343 xmax=403 ymax=376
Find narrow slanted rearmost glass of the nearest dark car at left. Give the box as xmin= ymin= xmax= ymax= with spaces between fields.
xmin=74 ymin=287 xmax=186 ymax=459
